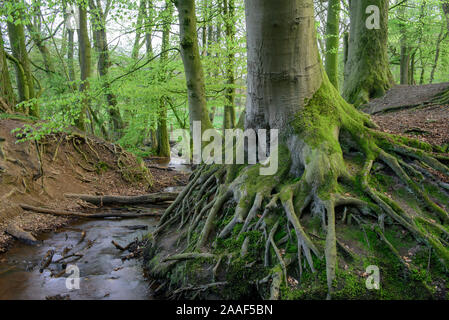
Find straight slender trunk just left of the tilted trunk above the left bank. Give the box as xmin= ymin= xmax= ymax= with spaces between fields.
xmin=75 ymin=6 xmax=92 ymax=131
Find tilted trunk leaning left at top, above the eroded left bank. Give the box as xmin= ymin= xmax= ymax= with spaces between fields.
xmin=89 ymin=0 xmax=124 ymax=140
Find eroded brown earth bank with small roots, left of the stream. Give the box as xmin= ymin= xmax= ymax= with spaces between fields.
xmin=0 ymin=119 xmax=188 ymax=253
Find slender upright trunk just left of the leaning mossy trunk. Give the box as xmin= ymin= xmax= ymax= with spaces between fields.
xmin=157 ymin=0 xmax=173 ymax=158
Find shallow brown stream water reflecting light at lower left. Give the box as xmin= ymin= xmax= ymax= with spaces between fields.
xmin=0 ymin=158 xmax=189 ymax=300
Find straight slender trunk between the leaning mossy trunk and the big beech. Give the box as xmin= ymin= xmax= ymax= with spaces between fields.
xmin=223 ymin=0 xmax=236 ymax=129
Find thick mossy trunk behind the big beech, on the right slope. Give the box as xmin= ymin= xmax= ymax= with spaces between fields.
xmin=343 ymin=0 xmax=393 ymax=106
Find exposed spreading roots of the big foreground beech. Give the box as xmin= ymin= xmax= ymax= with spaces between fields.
xmin=147 ymin=88 xmax=449 ymax=299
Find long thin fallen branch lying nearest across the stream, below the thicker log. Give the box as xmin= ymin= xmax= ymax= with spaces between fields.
xmin=20 ymin=204 xmax=161 ymax=219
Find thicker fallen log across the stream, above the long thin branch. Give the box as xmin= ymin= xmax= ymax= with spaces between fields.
xmin=64 ymin=192 xmax=178 ymax=206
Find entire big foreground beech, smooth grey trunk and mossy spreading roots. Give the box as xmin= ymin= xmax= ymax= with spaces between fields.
xmin=148 ymin=0 xmax=449 ymax=298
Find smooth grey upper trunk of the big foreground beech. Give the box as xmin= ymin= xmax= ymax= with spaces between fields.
xmin=246 ymin=0 xmax=323 ymax=138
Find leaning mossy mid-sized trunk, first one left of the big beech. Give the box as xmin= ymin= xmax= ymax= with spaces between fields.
xmin=175 ymin=0 xmax=212 ymax=135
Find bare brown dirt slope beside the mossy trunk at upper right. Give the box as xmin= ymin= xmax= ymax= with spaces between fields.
xmin=362 ymin=82 xmax=449 ymax=114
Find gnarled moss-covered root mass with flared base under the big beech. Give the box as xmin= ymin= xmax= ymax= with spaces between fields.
xmin=144 ymin=82 xmax=449 ymax=299
